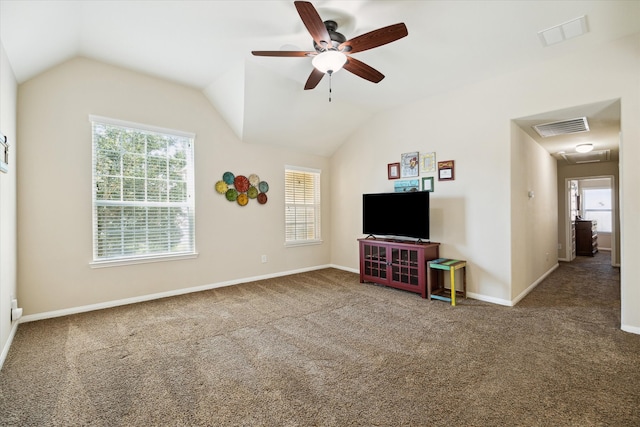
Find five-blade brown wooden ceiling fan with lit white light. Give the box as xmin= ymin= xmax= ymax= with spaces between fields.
xmin=251 ymin=1 xmax=409 ymax=90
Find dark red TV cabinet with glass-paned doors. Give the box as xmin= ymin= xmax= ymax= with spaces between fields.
xmin=358 ymin=238 xmax=440 ymax=298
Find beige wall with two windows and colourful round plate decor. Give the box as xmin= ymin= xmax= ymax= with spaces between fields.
xmin=18 ymin=58 xmax=331 ymax=316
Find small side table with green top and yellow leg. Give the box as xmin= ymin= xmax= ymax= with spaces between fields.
xmin=427 ymin=258 xmax=467 ymax=306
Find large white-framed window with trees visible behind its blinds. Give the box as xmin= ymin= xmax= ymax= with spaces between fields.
xmin=91 ymin=116 xmax=195 ymax=264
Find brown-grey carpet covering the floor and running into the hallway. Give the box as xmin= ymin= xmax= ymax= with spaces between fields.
xmin=0 ymin=253 xmax=640 ymax=426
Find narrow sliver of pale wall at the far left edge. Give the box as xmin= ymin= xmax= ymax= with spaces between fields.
xmin=0 ymin=41 xmax=18 ymax=367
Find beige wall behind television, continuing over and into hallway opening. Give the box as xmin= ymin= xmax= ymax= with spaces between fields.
xmin=332 ymin=34 xmax=640 ymax=333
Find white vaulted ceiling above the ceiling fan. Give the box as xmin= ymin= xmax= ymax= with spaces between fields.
xmin=0 ymin=0 xmax=640 ymax=156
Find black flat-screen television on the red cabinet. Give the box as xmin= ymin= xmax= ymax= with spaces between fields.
xmin=362 ymin=191 xmax=429 ymax=240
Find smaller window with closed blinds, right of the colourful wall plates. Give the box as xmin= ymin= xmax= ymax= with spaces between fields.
xmin=284 ymin=166 xmax=321 ymax=245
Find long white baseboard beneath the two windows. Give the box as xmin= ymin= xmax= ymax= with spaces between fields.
xmin=20 ymin=264 xmax=341 ymax=323
